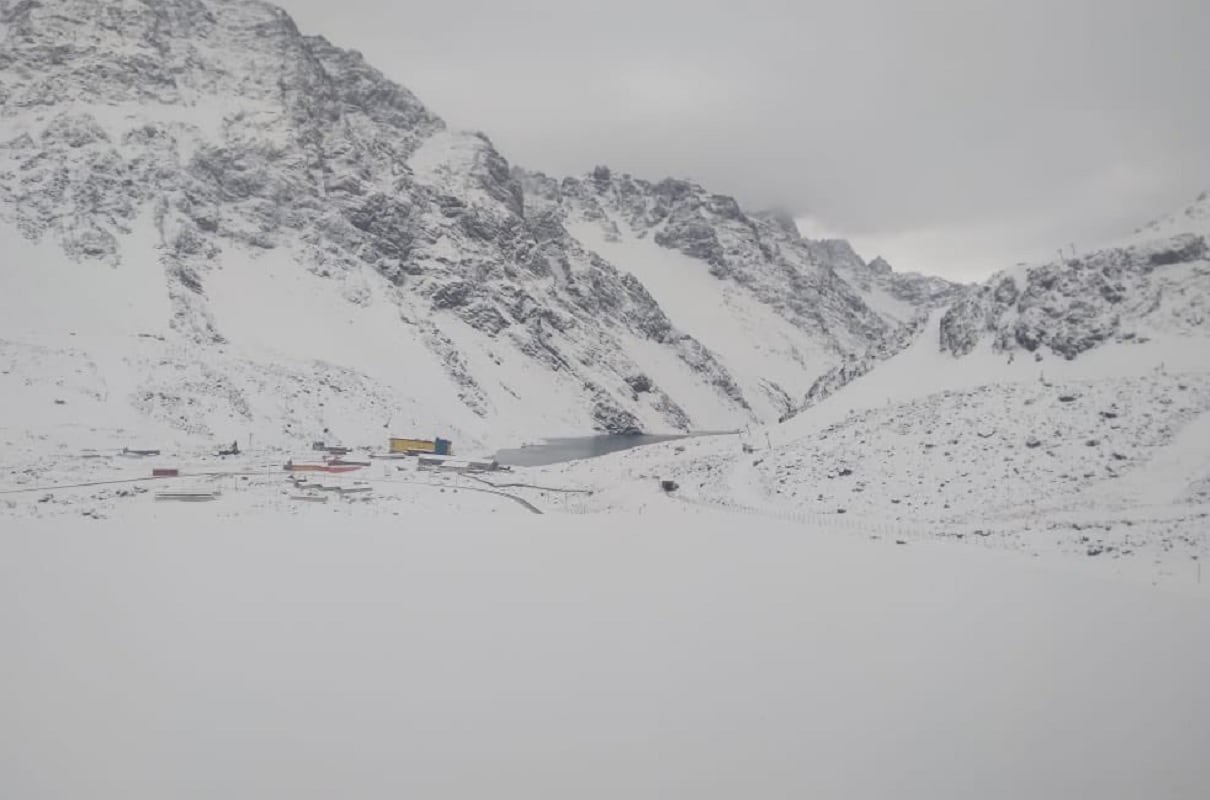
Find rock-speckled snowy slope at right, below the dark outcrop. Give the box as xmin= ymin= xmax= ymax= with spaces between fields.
xmin=759 ymin=373 xmax=1210 ymax=522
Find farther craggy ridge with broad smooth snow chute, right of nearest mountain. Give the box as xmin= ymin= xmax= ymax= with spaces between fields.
xmin=514 ymin=167 xmax=960 ymax=421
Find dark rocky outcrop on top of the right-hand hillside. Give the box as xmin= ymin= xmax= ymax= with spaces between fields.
xmin=940 ymin=234 xmax=1210 ymax=358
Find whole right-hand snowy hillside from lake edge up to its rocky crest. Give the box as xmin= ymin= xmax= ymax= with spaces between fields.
xmin=537 ymin=193 xmax=1210 ymax=586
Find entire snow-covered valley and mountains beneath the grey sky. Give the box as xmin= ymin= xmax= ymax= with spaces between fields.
xmin=0 ymin=0 xmax=1210 ymax=799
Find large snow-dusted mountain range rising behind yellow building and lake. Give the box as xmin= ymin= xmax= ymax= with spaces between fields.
xmin=0 ymin=0 xmax=953 ymax=452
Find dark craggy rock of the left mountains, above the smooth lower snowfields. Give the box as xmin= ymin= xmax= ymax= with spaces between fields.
xmin=0 ymin=0 xmax=948 ymax=442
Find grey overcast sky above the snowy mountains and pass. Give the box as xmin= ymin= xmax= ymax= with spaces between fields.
xmin=278 ymin=0 xmax=1210 ymax=278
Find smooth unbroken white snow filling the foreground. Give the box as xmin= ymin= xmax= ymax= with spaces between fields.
xmin=0 ymin=497 xmax=1210 ymax=800
